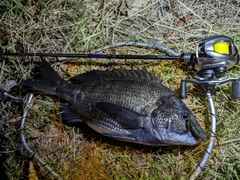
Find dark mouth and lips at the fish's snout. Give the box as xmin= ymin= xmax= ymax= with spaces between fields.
xmin=187 ymin=114 xmax=207 ymax=141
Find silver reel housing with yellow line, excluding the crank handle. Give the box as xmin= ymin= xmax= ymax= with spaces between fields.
xmin=193 ymin=36 xmax=239 ymax=78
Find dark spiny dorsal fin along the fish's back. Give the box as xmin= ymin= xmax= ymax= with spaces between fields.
xmin=72 ymin=67 xmax=161 ymax=84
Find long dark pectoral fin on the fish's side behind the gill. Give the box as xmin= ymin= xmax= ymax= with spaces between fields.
xmin=95 ymin=102 xmax=146 ymax=129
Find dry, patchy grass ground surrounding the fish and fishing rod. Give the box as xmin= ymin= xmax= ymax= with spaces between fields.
xmin=0 ymin=0 xmax=240 ymax=180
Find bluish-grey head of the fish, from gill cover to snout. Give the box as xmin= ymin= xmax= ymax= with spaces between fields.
xmin=151 ymin=95 xmax=206 ymax=145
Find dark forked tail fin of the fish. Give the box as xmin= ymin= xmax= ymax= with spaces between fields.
xmin=24 ymin=60 xmax=68 ymax=95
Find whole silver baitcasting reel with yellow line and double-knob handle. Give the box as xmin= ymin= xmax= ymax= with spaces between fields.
xmin=180 ymin=36 xmax=240 ymax=99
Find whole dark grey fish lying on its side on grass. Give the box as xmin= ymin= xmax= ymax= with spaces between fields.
xmin=24 ymin=60 xmax=207 ymax=146
